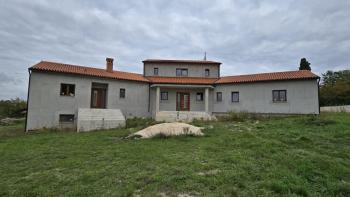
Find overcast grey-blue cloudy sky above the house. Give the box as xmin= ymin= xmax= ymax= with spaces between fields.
xmin=0 ymin=0 xmax=350 ymax=99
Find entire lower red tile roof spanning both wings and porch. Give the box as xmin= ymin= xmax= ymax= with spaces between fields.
xmin=30 ymin=61 xmax=319 ymax=85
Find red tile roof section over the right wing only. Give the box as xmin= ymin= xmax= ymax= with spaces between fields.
xmin=215 ymin=70 xmax=319 ymax=84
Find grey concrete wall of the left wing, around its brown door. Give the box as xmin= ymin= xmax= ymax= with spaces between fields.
xmin=27 ymin=72 xmax=150 ymax=130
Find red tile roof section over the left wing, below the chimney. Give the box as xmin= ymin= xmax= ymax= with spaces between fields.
xmin=30 ymin=61 xmax=149 ymax=82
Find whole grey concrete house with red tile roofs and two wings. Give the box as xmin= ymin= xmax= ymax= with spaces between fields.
xmin=26 ymin=58 xmax=319 ymax=131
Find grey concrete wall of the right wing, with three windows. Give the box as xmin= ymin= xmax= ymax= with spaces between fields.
xmin=213 ymin=80 xmax=319 ymax=114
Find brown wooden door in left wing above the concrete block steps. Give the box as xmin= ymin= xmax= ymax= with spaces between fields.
xmin=91 ymin=83 xmax=107 ymax=108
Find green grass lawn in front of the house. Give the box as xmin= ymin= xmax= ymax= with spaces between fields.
xmin=0 ymin=113 xmax=350 ymax=196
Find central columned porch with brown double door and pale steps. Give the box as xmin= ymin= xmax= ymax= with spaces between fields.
xmin=151 ymin=84 xmax=213 ymax=122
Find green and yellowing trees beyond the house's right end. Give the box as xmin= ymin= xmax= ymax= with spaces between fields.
xmin=320 ymin=70 xmax=350 ymax=106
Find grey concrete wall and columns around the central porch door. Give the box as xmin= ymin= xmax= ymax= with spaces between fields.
xmin=150 ymin=87 xmax=214 ymax=116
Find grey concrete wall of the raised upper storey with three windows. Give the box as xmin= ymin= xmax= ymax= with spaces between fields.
xmin=144 ymin=63 xmax=220 ymax=78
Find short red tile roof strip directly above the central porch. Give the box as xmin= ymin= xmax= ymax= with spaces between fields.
xmin=147 ymin=77 xmax=218 ymax=85
